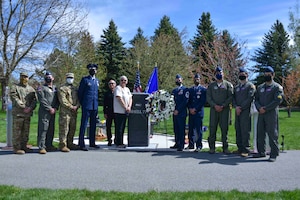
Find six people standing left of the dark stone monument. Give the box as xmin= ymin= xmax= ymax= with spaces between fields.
xmin=10 ymin=64 xmax=132 ymax=154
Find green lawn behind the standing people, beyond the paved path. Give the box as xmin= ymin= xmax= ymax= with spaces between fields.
xmin=0 ymin=107 xmax=300 ymax=150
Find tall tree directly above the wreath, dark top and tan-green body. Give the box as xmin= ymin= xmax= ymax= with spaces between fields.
xmin=150 ymin=16 xmax=191 ymax=91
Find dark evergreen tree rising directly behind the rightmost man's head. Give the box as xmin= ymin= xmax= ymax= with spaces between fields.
xmin=252 ymin=20 xmax=291 ymax=84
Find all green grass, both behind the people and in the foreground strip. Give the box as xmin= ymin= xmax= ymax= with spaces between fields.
xmin=0 ymin=107 xmax=300 ymax=200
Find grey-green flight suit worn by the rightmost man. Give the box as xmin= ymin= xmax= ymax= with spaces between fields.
xmin=255 ymin=81 xmax=283 ymax=158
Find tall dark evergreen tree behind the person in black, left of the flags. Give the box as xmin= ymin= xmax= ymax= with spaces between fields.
xmin=97 ymin=20 xmax=126 ymax=94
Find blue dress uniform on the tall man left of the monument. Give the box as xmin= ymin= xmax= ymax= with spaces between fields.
xmin=78 ymin=76 xmax=99 ymax=148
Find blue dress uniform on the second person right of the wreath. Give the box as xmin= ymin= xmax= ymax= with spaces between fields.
xmin=188 ymin=85 xmax=206 ymax=149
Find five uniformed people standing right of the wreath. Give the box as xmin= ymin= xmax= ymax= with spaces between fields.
xmin=170 ymin=66 xmax=283 ymax=162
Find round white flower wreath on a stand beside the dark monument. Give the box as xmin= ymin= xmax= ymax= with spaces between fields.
xmin=145 ymin=90 xmax=175 ymax=122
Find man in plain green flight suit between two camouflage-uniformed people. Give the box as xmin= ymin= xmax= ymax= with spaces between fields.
xmin=37 ymin=72 xmax=59 ymax=154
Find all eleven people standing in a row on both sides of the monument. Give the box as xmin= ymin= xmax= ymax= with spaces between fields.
xmin=10 ymin=64 xmax=283 ymax=161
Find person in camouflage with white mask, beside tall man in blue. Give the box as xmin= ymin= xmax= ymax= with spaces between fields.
xmin=58 ymin=73 xmax=80 ymax=152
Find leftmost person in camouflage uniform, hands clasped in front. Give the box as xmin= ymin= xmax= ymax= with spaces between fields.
xmin=10 ymin=72 xmax=37 ymax=154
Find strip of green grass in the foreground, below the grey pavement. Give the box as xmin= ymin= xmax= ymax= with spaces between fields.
xmin=0 ymin=186 xmax=300 ymax=200
